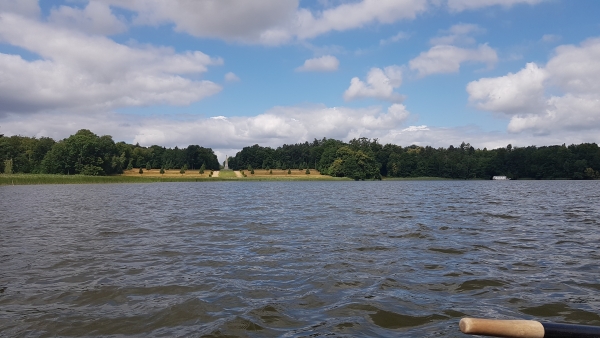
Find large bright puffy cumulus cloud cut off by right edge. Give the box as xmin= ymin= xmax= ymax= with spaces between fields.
xmin=467 ymin=38 xmax=600 ymax=135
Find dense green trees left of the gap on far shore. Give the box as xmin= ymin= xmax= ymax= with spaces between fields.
xmin=0 ymin=129 xmax=219 ymax=175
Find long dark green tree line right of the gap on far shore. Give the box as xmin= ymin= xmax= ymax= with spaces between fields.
xmin=229 ymin=138 xmax=600 ymax=180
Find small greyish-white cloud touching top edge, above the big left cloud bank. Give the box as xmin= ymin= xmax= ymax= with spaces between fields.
xmin=48 ymin=1 xmax=127 ymax=35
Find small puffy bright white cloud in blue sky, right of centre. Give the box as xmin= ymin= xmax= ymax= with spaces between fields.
xmin=344 ymin=66 xmax=404 ymax=102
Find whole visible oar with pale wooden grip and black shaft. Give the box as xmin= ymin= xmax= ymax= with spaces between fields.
xmin=459 ymin=318 xmax=600 ymax=338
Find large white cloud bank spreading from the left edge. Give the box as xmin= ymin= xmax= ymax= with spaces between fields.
xmin=0 ymin=13 xmax=222 ymax=113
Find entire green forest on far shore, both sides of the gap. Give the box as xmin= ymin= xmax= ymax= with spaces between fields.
xmin=0 ymin=129 xmax=600 ymax=180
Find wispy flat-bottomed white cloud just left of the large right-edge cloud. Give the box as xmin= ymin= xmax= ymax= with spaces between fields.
xmin=409 ymin=45 xmax=498 ymax=77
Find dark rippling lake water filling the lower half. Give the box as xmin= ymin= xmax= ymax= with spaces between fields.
xmin=0 ymin=181 xmax=600 ymax=337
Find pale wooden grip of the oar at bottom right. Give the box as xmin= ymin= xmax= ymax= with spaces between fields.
xmin=459 ymin=318 xmax=544 ymax=338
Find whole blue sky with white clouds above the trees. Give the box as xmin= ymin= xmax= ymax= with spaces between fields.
xmin=0 ymin=0 xmax=600 ymax=161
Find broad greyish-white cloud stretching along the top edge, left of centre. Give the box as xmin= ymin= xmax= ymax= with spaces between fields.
xmin=98 ymin=0 xmax=428 ymax=45
